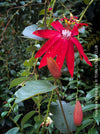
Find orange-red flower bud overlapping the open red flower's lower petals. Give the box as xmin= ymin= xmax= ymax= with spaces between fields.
xmin=47 ymin=57 xmax=61 ymax=79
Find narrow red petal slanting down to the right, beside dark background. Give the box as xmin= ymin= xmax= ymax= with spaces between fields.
xmin=71 ymin=37 xmax=92 ymax=66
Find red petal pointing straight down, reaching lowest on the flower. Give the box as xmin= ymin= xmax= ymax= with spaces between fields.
xmin=66 ymin=41 xmax=74 ymax=77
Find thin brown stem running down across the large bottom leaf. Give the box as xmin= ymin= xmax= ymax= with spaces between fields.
xmin=55 ymin=79 xmax=70 ymax=134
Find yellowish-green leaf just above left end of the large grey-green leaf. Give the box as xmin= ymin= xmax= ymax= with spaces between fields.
xmin=9 ymin=77 xmax=27 ymax=89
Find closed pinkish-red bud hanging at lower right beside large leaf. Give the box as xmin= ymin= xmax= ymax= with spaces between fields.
xmin=74 ymin=101 xmax=83 ymax=126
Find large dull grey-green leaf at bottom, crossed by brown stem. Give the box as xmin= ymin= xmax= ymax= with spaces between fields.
xmin=50 ymin=101 xmax=76 ymax=134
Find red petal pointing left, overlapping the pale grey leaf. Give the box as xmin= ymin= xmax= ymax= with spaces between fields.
xmin=33 ymin=29 xmax=59 ymax=39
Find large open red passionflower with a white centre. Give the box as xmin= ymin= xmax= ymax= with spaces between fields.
xmin=33 ymin=21 xmax=92 ymax=77
